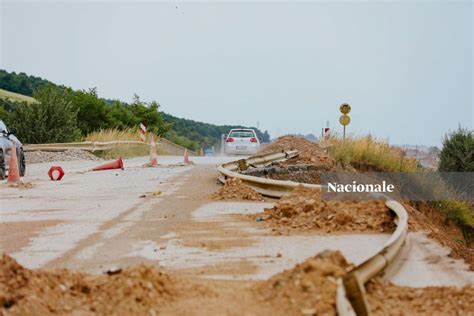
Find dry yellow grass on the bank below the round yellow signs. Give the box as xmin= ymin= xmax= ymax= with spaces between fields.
xmin=325 ymin=136 xmax=418 ymax=172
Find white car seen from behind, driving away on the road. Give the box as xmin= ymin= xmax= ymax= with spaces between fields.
xmin=225 ymin=129 xmax=260 ymax=155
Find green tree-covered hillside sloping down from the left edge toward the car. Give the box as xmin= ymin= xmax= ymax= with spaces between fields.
xmin=0 ymin=70 xmax=270 ymax=151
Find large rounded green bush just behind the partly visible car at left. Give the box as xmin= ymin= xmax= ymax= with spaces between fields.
xmin=12 ymin=85 xmax=80 ymax=143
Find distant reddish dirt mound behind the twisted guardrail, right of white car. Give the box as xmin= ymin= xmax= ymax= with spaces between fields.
xmin=260 ymin=135 xmax=334 ymax=166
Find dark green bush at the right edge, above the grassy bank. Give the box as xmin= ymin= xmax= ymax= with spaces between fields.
xmin=438 ymin=127 xmax=474 ymax=172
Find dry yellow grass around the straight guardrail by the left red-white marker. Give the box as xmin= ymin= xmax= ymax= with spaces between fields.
xmin=84 ymin=128 xmax=164 ymax=159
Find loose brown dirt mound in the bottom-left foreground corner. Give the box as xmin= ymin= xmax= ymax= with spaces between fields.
xmin=0 ymin=254 xmax=177 ymax=315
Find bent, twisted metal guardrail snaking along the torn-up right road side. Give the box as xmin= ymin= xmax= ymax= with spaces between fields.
xmin=218 ymin=150 xmax=408 ymax=316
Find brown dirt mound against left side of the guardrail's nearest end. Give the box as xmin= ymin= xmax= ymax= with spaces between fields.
xmin=255 ymin=251 xmax=351 ymax=315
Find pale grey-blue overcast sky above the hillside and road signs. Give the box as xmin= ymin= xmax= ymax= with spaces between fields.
xmin=0 ymin=0 xmax=474 ymax=145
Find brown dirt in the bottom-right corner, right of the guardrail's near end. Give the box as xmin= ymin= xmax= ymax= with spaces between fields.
xmin=367 ymin=278 xmax=474 ymax=315
